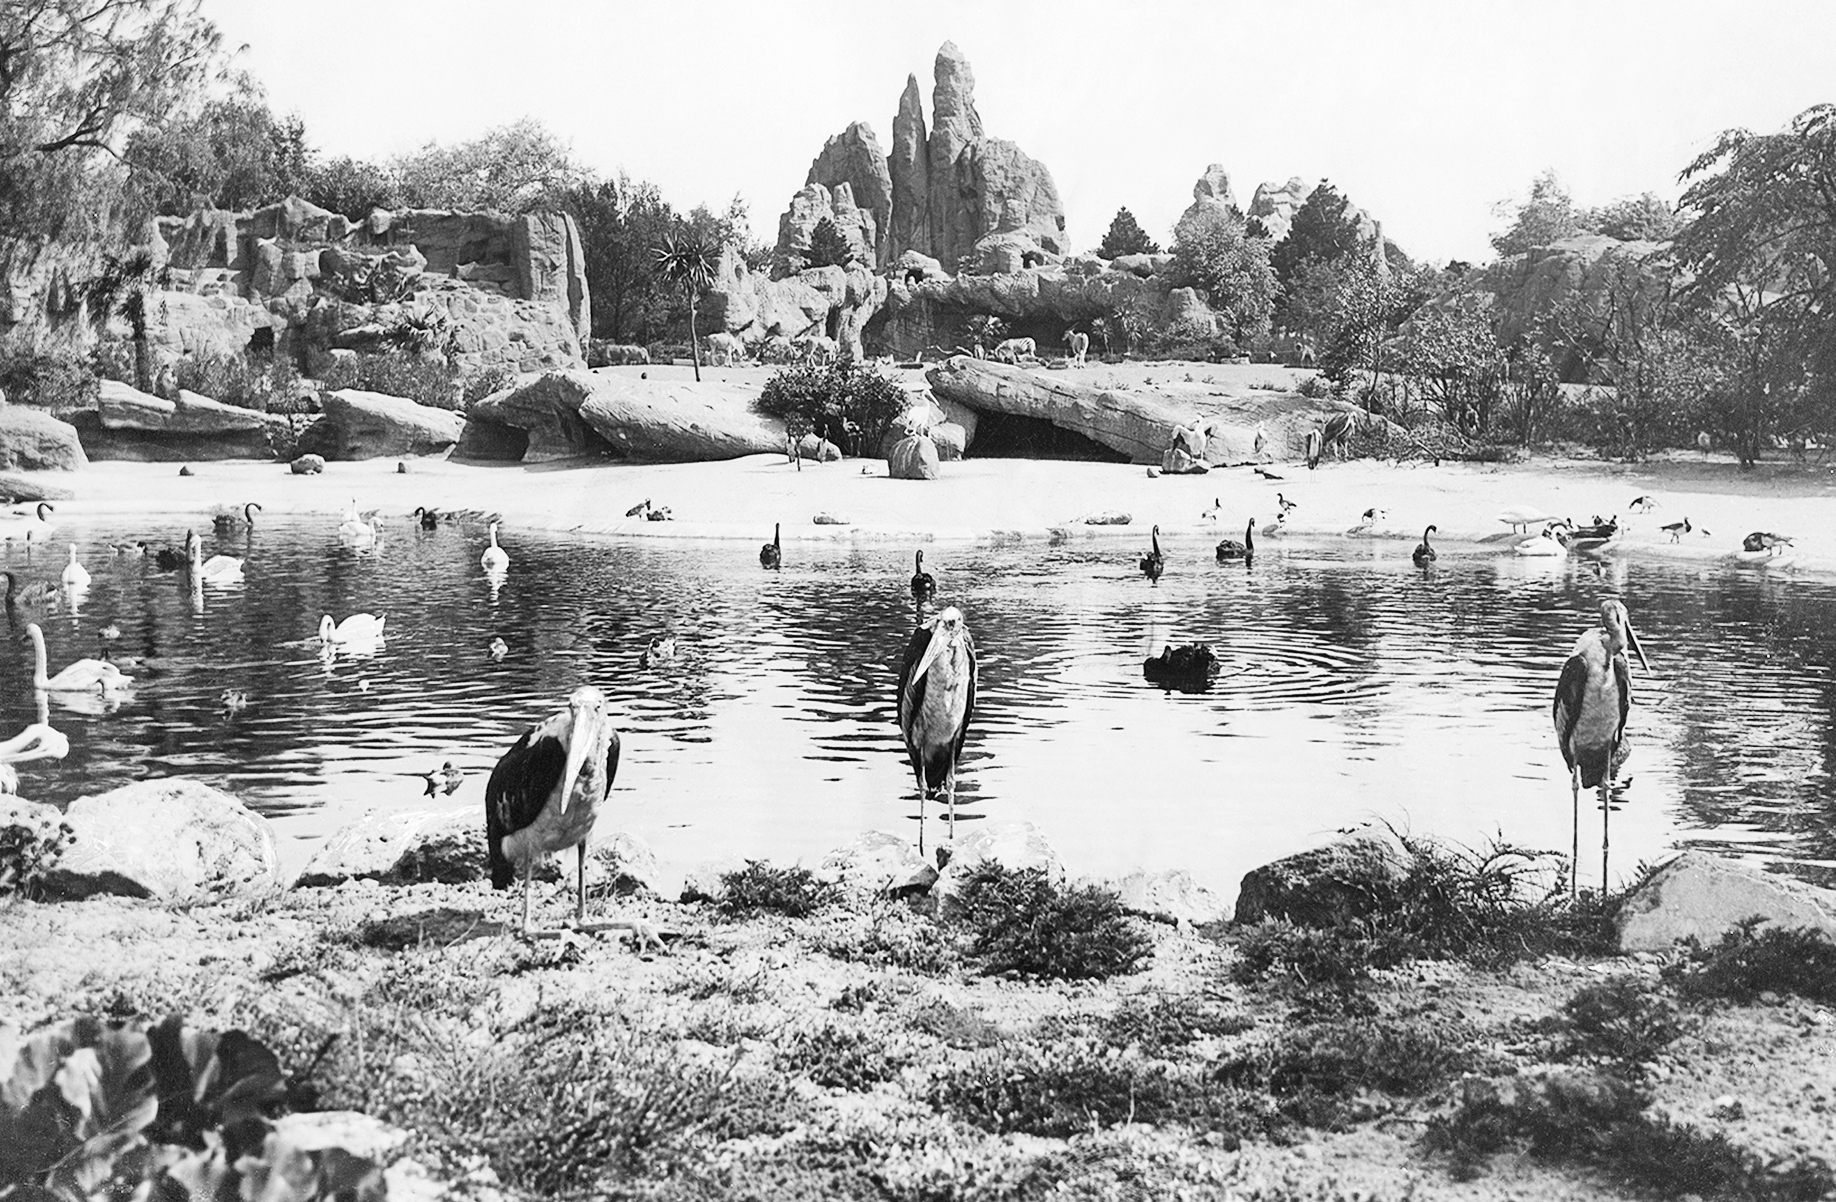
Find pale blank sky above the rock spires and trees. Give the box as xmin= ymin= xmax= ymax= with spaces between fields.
xmin=204 ymin=0 xmax=1836 ymax=262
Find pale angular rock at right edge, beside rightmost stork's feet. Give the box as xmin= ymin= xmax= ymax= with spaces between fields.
xmin=1619 ymin=851 xmax=1836 ymax=952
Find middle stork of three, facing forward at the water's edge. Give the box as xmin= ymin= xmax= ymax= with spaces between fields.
xmin=900 ymin=606 xmax=975 ymax=853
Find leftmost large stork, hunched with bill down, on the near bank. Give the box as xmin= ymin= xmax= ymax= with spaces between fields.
xmin=485 ymin=684 xmax=661 ymax=952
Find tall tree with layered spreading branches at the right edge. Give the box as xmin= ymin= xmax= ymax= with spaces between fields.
xmin=1674 ymin=105 xmax=1836 ymax=466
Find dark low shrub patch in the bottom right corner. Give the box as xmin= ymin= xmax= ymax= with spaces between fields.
xmin=1423 ymin=1072 xmax=1836 ymax=1202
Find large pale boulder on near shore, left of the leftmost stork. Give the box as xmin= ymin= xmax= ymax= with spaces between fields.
xmin=44 ymin=776 xmax=281 ymax=901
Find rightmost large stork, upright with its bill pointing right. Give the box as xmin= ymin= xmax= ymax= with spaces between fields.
xmin=1551 ymin=600 xmax=1651 ymax=896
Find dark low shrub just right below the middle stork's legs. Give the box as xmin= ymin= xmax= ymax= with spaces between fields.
xmin=951 ymin=861 xmax=1153 ymax=980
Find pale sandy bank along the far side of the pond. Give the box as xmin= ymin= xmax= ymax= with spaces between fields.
xmin=21 ymin=445 xmax=1836 ymax=573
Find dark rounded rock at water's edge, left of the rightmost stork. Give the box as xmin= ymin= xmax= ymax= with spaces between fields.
xmin=1236 ymin=831 xmax=1408 ymax=927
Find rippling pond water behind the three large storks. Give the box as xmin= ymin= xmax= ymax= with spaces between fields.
xmin=0 ymin=519 xmax=1836 ymax=888
